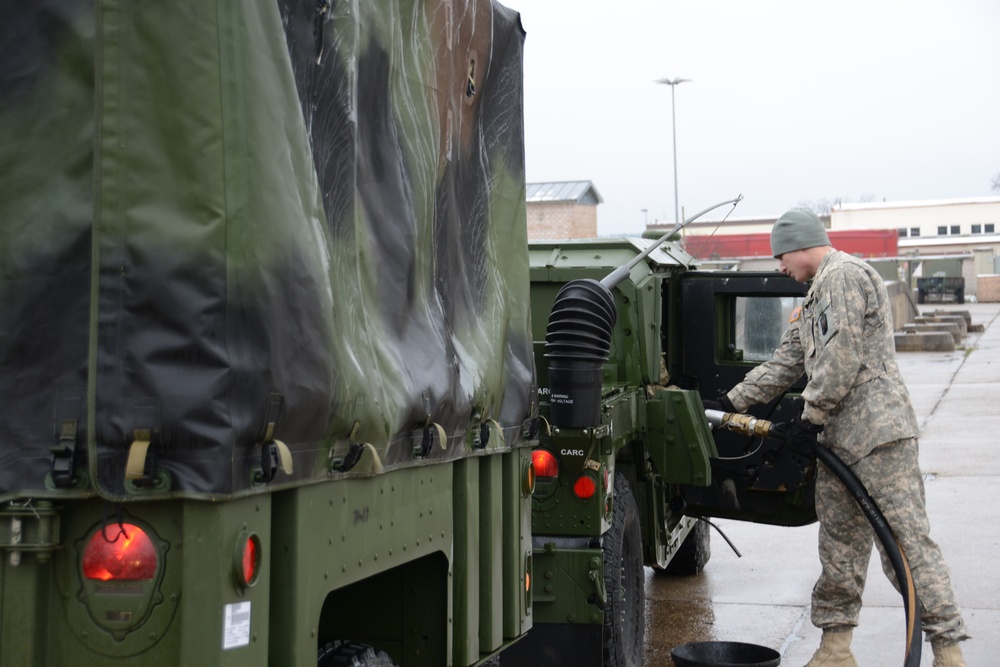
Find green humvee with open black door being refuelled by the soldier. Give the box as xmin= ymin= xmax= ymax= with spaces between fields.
xmin=501 ymin=237 xmax=815 ymax=667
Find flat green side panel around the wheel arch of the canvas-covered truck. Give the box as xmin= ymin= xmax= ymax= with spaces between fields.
xmin=271 ymin=464 xmax=455 ymax=665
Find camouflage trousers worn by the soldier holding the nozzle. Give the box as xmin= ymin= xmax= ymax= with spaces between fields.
xmin=812 ymin=438 xmax=968 ymax=644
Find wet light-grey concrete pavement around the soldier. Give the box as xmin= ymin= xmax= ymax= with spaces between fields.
xmin=646 ymin=303 xmax=1000 ymax=667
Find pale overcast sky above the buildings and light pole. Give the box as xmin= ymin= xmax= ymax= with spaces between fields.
xmin=516 ymin=0 xmax=1000 ymax=235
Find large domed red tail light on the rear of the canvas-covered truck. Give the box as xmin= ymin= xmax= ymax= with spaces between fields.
xmin=83 ymin=523 xmax=158 ymax=581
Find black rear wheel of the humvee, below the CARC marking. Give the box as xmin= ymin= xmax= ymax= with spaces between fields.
xmin=603 ymin=475 xmax=646 ymax=667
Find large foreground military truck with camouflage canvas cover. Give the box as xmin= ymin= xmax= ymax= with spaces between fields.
xmin=0 ymin=0 xmax=537 ymax=667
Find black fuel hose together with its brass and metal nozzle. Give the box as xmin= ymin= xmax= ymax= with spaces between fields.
xmin=705 ymin=410 xmax=921 ymax=667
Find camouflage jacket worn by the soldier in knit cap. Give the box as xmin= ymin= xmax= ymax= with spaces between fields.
xmin=728 ymin=251 xmax=919 ymax=464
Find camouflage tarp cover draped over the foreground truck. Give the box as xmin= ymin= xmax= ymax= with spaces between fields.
xmin=0 ymin=0 xmax=534 ymax=500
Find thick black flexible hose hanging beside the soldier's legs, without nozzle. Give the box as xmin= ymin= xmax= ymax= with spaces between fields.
xmin=816 ymin=443 xmax=921 ymax=667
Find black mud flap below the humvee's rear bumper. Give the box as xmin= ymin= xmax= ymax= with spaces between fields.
xmin=500 ymin=623 xmax=604 ymax=667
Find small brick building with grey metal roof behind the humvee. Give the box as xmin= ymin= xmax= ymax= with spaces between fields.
xmin=526 ymin=181 xmax=604 ymax=240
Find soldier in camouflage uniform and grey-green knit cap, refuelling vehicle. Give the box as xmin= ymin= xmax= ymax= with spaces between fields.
xmin=705 ymin=211 xmax=969 ymax=667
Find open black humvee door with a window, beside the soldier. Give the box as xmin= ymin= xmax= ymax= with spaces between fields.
xmin=664 ymin=271 xmax=816 ymax=526
